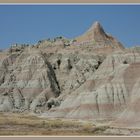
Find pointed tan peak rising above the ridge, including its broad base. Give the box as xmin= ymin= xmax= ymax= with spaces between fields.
xmin=75 ymin=22 xmax=124 ymax=53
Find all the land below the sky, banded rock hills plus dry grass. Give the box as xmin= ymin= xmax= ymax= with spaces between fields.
xmin=0 ymin=22 xmax=140 ymax=135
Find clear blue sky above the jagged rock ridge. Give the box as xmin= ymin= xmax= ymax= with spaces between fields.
xmin=0 ymin=5 xmax=140 ymax=49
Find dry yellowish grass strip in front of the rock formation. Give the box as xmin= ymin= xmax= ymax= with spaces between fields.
xmin=0 ymin=113 xmax=107 ymax=136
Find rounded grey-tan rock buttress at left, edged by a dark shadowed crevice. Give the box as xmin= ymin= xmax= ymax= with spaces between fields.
xmin=0 ymin=52 xmax=60 ymax=111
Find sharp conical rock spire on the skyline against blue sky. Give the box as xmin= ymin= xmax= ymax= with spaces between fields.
xmin=76 ymin=21 xmax=124 ymax=50
